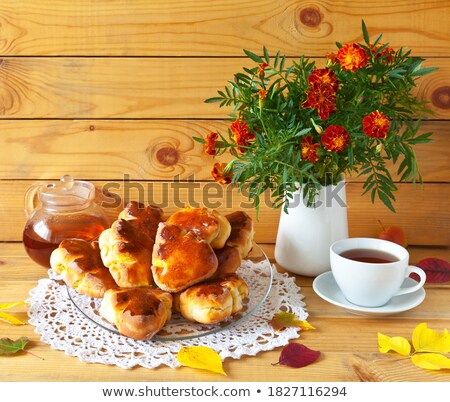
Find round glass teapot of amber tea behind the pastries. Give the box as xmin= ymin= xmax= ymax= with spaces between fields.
xmin=23 ymin=175 xmax=109 ymax=267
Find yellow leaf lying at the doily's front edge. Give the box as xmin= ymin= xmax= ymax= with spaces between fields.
xmin=177 ymin=346 xmax=227 ymax=375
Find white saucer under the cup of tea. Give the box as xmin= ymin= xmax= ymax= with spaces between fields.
xmin=313 ymin=271 xmax=425 ymax=316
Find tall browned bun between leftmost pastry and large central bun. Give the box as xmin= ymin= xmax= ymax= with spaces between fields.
xmin=98 ymin=219 xmax=154 ymax=288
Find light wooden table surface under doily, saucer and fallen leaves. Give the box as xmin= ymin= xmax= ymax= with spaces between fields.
xmin=0 ymin=242 xmax=450 ymax=382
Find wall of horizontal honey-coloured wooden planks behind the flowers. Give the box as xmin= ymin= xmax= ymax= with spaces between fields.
xmin=0 ymin=0 xmax=450 ymax=246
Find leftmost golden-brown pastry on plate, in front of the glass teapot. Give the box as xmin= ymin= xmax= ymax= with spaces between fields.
xmin=50 ymin=239 xmax=117 ymax=297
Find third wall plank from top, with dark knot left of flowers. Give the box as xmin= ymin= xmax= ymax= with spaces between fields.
xmin=0 ymin=120 xmax=450 ymax=182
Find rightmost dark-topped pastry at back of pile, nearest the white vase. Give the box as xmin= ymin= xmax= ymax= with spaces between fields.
xmin=225 ymin=211 xmax=254 ymax=259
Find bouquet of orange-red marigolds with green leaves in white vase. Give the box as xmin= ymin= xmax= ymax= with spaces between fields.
xmin=194 ymin=21 xmax=435 ymax=211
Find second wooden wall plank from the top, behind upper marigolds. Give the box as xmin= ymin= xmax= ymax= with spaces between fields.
xmin=0 ymin=57 xmax=450 ymax=119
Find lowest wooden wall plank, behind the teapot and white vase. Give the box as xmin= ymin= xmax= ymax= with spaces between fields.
xmin=0 ymin=180 xmax=450 ymax=246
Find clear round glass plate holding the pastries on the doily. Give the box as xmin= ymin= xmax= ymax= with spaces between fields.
xmin=67 ymin=243 xmax=273 ymax=341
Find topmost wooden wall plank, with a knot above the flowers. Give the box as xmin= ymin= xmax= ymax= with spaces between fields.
xmin=0 ymin=0 xmax=450 ymax=56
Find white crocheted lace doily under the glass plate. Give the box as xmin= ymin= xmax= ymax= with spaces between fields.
xmin=27 ymin=260 xmax=308 ymax=368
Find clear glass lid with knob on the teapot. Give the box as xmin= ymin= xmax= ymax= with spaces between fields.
xmin=38 ymin=174 xmax=95 ymax=207
